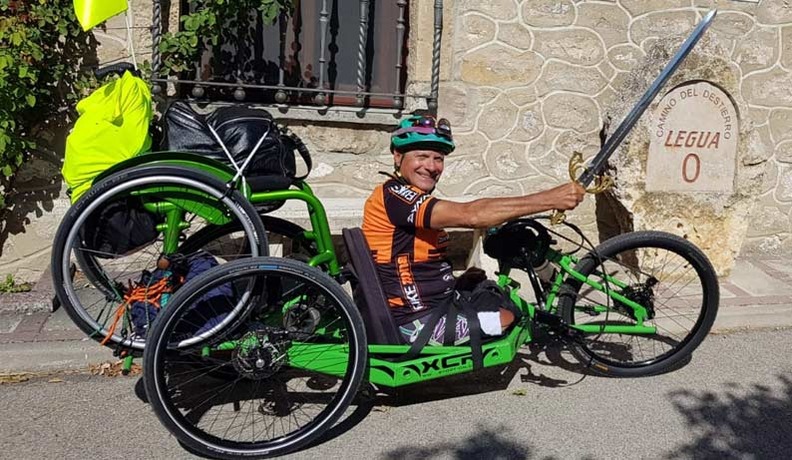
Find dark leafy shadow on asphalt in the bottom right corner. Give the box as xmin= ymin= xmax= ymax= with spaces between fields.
xmin=667 ymin=376 xmax=792 ymax=460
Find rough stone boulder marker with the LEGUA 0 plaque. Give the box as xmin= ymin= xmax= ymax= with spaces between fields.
xmin=596 ymin=35 xmax=772 ymax=276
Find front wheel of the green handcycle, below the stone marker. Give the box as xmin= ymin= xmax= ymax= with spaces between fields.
xmin=559 ymin=231 xmax=719 ymax=377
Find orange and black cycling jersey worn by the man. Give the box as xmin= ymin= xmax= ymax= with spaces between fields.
xmin=363 ymin=179 xmax=454 ymax=324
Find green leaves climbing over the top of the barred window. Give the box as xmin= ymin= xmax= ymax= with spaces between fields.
xmin=160 ymin=0 xmax=294 ymax=73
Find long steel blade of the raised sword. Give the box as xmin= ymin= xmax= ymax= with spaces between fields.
xmin=578 ymin=10 xmax=717 ymax=186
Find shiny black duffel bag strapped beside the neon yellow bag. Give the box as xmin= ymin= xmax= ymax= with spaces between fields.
xmin=160 ymin=101 xmax=311 ymax=180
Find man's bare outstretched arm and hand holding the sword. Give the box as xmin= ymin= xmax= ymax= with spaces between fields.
xmin=430 ymin=183 xmax=586 ymax=229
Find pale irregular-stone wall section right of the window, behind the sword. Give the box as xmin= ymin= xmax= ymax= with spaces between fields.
xmin=439 ymin=0 xmax=792 ymax=273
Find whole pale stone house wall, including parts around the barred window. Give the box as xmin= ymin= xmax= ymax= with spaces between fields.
xmin=0 ymin=0 xmax=792 ymax=281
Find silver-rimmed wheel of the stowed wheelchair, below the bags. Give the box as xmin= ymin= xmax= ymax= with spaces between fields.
xmin=52 ymin=166 xmax=268 ymax=350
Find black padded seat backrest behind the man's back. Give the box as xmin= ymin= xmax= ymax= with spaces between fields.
xmin=341 ymin=228 xmax=404 ymax=345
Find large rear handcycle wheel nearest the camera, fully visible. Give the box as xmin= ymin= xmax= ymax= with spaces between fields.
xmin=143 ymin=257 xmax=367 ymax=458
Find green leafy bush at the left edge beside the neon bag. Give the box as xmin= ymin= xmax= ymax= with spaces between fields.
xmin=0 ymin=0 xmax=93 ymax=209
